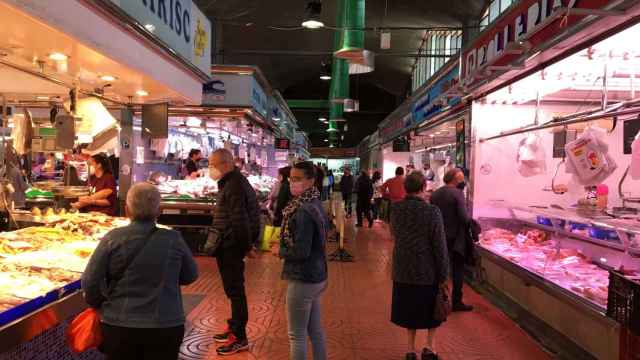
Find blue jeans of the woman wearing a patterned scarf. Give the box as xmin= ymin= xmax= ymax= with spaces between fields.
xmin=287 ymin=280 xmax=327 ymax=360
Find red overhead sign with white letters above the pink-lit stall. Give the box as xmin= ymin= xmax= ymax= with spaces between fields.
xmin=462 ymin=0 xmax=610 ymax=85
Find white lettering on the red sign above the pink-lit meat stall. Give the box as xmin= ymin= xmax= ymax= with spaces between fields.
xmin=462 ymin=0 xmax=578 ymax=82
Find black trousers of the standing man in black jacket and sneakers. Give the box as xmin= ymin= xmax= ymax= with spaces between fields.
xmin=216 ymin=247 xmax=249 ymax=340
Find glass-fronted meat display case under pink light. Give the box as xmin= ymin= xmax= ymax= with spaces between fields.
xmin=476 ymin=202 xmax=640 ymax=359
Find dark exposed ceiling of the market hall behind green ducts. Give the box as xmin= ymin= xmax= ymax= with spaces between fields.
xmin=196 ymin=0 xmax=486 ymax=147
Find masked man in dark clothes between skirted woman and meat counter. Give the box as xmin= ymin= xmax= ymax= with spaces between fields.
xmin=431 ymin=168 xmax=473 ymax=311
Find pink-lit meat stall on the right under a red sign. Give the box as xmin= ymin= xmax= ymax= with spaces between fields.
xmin=462 ymin=1 xmax=640 ymax=359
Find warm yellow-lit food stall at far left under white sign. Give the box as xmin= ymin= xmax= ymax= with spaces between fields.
xmin=0 ymin=0 xmax=210 ymax=359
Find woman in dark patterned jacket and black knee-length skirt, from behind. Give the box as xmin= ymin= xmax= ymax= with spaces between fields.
xmin=391 ymin=171 xmax=449 ymax=360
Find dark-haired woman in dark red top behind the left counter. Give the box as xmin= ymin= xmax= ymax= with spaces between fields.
xmin=71 ymin=154 xmax=117 ymax=216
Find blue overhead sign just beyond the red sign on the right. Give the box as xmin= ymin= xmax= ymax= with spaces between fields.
xmin=412 ymin=66 xmax=460 ymax=124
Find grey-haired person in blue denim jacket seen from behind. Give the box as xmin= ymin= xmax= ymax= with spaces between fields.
xmin=82 ymin=183 xmax=198 ymax=360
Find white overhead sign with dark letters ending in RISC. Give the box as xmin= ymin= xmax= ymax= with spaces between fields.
xmin=111 ymin=0 xmax=212 ymax=74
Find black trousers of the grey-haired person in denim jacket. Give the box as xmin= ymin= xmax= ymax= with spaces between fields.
xmin=101 ymin=323 xmax=184 ymax=360
